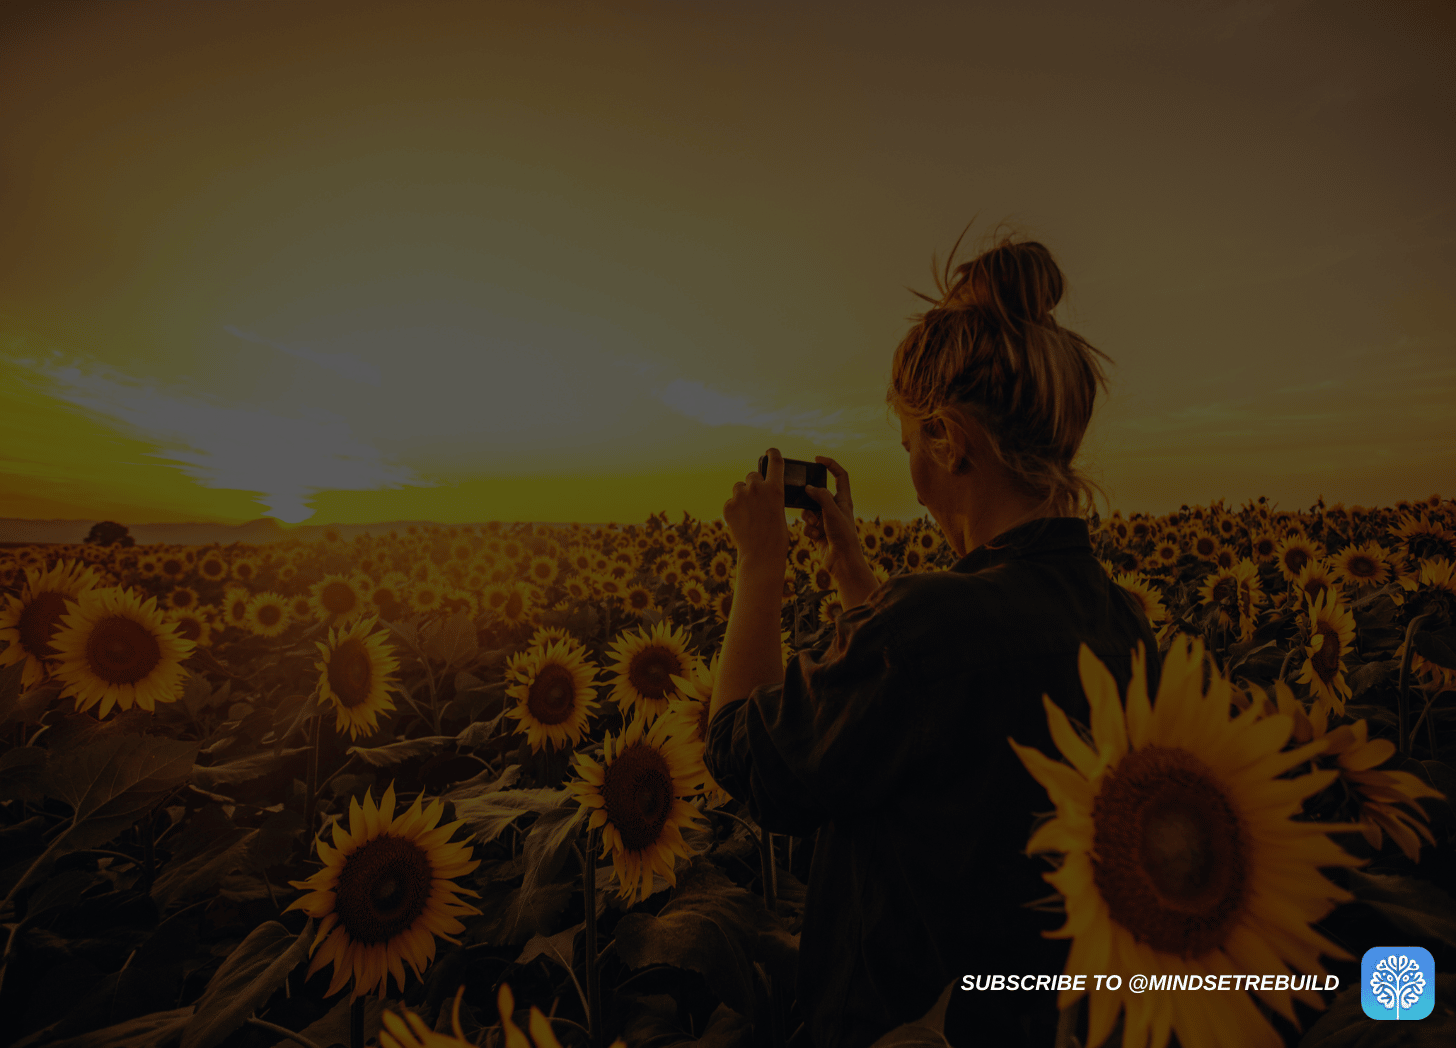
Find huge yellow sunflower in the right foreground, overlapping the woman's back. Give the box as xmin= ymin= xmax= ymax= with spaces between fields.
xmin=1009 ymin=640 xmax=1360 ymax=1048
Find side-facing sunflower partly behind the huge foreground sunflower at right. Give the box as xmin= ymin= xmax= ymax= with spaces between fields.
xmin=1264 ymin=680 xmax=1446 ymax=862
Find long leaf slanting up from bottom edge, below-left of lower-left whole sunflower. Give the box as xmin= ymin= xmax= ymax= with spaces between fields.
xmin=182 ymin=917 xmax=313 ymax=1048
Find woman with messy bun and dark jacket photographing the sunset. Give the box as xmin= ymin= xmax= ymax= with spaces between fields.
xmin=705 ymin=234 xmax=1159 ymax=1048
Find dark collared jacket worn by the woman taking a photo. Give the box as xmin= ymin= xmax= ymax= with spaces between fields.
xmin=705 ymin=517 xmax=1159 ymax=1048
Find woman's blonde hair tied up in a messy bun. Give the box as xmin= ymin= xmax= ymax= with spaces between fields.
xmin=885 ymin=218 xmax=1111 ymax=517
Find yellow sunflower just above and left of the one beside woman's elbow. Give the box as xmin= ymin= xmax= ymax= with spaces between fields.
xmin=505 ymin=640 xmax=598 ymax=753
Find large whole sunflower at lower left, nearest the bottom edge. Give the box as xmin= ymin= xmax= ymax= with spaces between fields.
xmin=287 ymin=783 xmax=480 ymax=1000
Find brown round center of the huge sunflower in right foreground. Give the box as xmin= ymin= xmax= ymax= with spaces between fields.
xmin=1092 ymin=747 xmax=1248 ymax=956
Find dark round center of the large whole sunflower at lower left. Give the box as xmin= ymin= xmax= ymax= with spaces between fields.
xmin=333 ymin=834 xmax=434 ymax=946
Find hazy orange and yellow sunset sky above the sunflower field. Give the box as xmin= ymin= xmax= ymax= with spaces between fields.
xmin=0 ymin=0 xmax=1456 ymax=524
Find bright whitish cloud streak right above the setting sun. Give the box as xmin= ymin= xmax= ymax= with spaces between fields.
xmin=15 ymin=358 xmax=434 ymax=524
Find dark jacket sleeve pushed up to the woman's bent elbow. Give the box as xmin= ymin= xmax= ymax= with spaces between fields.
xmin=703 ymin=579 xmax=927 ymax=837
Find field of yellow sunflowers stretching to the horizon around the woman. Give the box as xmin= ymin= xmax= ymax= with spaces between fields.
xmin=0 ymin=495 xmax=1456 ymax=1048
